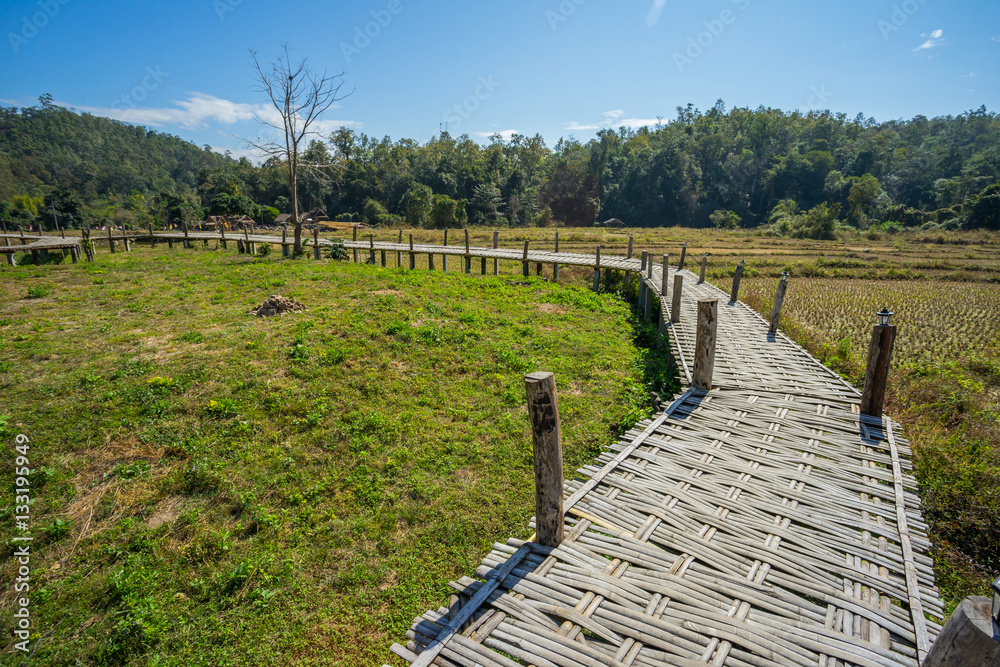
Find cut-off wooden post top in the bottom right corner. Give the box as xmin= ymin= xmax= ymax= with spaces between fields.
xmin=922 ymin=596 xmax=1000 ymax=667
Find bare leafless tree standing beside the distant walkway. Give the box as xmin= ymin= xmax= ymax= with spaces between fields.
xmin=244 ymin=44 xmax=350 ymax=253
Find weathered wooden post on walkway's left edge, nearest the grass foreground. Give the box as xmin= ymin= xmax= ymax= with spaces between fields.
xmin=524 ymin=373 xmax=564 ymax=547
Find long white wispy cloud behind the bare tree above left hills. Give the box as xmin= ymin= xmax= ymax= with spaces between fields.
xmin=59 ymin=93 xmax=361 ymax=134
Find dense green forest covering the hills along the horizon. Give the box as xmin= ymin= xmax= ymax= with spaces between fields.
xmin=0 ymin=97 xmax=1000 ymax=238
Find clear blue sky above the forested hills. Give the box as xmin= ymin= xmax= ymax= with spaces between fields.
xmin=0 ymin=0 xmax=1000 ymax=160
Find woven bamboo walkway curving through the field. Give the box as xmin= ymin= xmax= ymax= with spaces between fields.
xmin=376 ymin=252 xmax=943 ymax=667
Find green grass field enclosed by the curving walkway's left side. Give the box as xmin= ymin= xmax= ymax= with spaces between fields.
xmin=0 ymin=247 xmax=655 ymax=665
